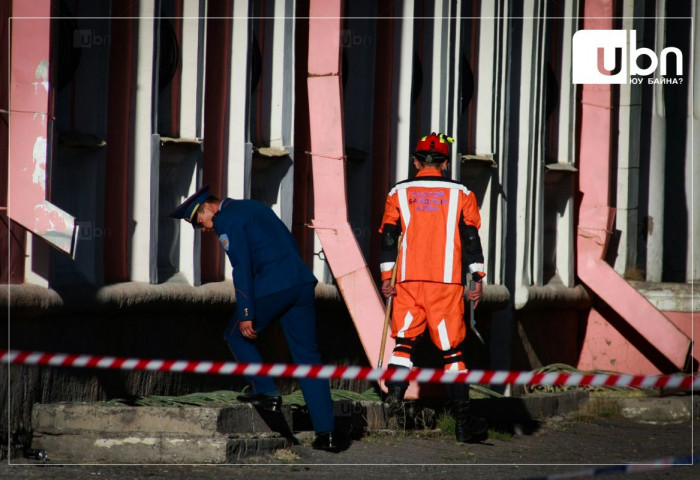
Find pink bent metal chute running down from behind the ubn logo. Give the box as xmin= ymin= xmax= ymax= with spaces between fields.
xmin=576 ymin=0 xmax=692 ymax=369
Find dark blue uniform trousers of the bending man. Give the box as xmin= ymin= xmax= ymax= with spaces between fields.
xmin=224 ymin=283 xmax=334 ymax=433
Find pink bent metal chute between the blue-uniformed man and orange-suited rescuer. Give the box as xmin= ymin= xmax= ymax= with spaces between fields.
xmin=307 ymin=0 xmax=391 ymax=376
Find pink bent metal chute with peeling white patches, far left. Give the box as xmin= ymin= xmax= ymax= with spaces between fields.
xmin=8 ymin=0 xmax=76 ymax=254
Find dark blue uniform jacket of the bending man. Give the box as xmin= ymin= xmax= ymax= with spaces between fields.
xmin=214 ymin=198 xmax=317 ymax=321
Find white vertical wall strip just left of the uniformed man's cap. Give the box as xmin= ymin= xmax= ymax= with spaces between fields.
xmin=129 ymin=4 xmax=157 ymax=282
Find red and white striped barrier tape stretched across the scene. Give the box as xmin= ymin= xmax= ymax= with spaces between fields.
xmin=0 ymin=350 xmax=700 ymax=390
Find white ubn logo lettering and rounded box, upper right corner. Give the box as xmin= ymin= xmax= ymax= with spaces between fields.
xmin=572 ymin=30 xmax=683 ymax=84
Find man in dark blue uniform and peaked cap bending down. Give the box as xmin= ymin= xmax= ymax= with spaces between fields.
xmin=170 ymin=186 xmax=348 ymax=452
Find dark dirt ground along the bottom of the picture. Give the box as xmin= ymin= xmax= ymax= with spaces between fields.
xmin=0 ymin=417 xmax=700 ymax=480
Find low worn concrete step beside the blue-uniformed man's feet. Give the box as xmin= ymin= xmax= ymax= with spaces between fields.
xmin=32 ymin=403 xmax=293 ymax=463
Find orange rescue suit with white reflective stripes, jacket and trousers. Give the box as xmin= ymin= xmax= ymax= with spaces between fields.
xmin=379 ymin=170 xmax=484 ymax=371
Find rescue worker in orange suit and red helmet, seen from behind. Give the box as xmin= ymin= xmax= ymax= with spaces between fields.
xmin=379 ymin=133 xmax=488 ymax=442
